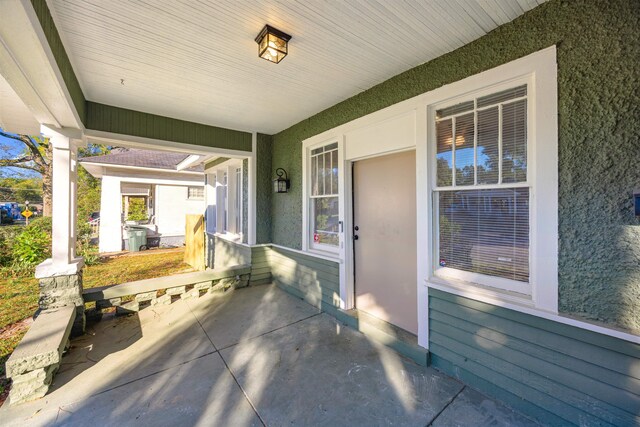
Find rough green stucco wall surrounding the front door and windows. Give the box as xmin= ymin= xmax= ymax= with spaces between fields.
xmin=271 ymin=0 xmax=640 ymax=332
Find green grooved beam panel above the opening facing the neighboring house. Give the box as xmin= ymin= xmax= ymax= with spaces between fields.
xmin=86 ymin=101 xmax=251 ymax=152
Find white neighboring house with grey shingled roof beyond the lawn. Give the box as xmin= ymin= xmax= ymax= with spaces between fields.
xmin=80 ymin=149 xmax=205 ymax=252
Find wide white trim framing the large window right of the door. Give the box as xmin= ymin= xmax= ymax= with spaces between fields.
xmin=426 ymin=48 xmax=558 ymax=314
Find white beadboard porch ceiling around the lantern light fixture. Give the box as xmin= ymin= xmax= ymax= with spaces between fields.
xmin=48 ymin=0 xmax=544 ymax=134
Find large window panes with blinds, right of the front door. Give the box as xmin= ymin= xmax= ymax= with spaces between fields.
xmin=434 ymin=85 xmax=530 ymax=283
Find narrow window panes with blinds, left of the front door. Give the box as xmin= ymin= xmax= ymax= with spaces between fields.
xmin=309 ymin=143 xmax=339 ymax=247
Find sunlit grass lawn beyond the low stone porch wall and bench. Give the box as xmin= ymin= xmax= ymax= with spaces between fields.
xmin=0 ymin=249 xmax=192 ymax=404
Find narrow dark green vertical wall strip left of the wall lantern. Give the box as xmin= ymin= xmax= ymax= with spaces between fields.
xmin=256 ymin=133 xmax=274 ymax=243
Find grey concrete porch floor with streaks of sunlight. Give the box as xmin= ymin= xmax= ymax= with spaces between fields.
xmin=0 ymin=285 xmax=535 ymax=426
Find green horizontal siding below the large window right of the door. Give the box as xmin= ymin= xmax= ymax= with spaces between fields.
xmin=429 ymin=290 xmax=640 ymax=426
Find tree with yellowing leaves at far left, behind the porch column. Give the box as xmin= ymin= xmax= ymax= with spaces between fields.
xmin=0 ymin=129 xmax=53 ymax=216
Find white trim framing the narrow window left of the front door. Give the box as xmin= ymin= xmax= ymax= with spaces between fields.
xmin=302 ymin=138 xmax=344 ymax=258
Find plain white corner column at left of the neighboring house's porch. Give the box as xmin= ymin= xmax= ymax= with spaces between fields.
xmin=98 ymin=175 xmax=122 ymax=252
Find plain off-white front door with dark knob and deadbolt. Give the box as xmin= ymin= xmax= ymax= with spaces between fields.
xmin=353 ymin=150 xmax=418 ymax=334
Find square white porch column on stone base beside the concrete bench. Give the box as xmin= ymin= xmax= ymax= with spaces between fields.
xmin=36 ymin=125 xmax=85 ymax=335
